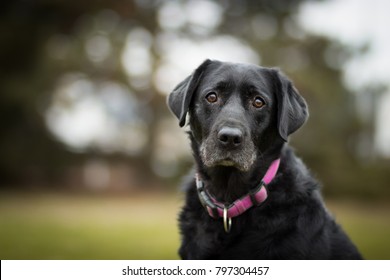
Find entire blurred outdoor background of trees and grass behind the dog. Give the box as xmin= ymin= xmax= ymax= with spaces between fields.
xmin=0 ymin=0 xmax=390 ymax=259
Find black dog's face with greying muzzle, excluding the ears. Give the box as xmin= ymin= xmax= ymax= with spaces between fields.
xmin=189 ymin=61 xmax=276 ymax=171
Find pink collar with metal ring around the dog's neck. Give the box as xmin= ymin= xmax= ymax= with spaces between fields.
xmin=196 ymin=159 xmax=280 ymax=232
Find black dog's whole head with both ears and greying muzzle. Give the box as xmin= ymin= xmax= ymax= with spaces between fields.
xmin=168 ymin=60 xmax=308 ymax=171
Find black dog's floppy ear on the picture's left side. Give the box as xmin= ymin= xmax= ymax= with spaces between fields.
xmin=167 ymin=59 xmax=212 ymax=127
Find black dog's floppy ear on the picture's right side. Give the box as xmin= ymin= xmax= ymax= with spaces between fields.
xmin=273 ymin=69 xmax=309 ymax=141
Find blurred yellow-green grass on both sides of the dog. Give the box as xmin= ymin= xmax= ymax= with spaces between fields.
xmin=0 ymin=193 xmax=390 ymax=259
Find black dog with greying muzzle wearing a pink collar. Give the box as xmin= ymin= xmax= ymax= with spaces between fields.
xmin=168 ymin=60 xmax=361 ymax=259
